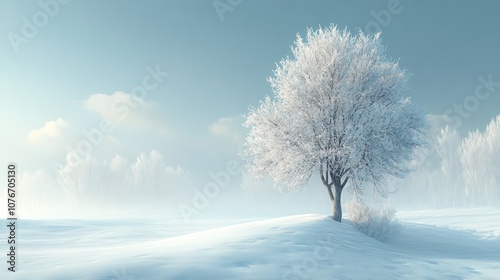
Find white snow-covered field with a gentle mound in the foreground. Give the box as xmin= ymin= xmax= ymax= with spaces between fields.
xmin=0 ymin=209 xmax=500 ymax=279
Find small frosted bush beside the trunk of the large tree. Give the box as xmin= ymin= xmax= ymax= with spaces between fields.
xmin=346 ymin=201 xmax=403 ymax=242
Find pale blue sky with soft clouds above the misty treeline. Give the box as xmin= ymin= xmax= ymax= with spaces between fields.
xmin=0 ymin=0 xmax=500 ymax=179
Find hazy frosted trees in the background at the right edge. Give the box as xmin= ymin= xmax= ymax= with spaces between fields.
xmin=392 ymin=116 xmax=500 ymax=208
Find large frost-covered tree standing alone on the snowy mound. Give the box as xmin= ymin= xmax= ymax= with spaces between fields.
xmin=244 ymin=25 xmax=428 ymax=222
